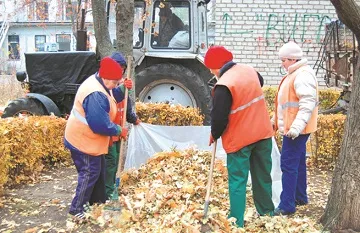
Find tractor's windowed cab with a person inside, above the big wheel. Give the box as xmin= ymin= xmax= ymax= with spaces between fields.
xmin=108 ymin=0 xmax=208 ymax=60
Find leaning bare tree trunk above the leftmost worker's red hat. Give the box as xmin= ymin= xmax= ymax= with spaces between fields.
xmin=91 ymin=0 xmax=114 ymax=58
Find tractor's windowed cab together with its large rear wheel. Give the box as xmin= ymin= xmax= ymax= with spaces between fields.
xmin=108 ymin=0 xmax=213 ymax=123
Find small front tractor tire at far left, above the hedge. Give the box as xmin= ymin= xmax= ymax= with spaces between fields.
xmin=1 ymin=98 xmax=48 ymax=118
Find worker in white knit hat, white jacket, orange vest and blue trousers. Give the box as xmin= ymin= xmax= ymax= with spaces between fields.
xmin=272 ymin=41 xmax=319 ymax=215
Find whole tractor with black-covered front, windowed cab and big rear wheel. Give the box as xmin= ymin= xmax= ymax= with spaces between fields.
xmin=2 ymin=0 xmax=215 ymax=124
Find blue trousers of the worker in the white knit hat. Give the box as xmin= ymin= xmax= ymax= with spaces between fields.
xmin=279 ymin=134 xmax=309 ymax=213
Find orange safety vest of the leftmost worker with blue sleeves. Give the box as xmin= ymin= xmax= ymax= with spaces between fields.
xmin=65 ymin=75 xmax=116 ymax=156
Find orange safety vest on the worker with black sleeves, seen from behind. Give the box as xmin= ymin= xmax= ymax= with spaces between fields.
xmin=216 ymin=64 xmax=273 ymax=153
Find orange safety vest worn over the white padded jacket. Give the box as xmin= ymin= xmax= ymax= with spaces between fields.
xmin=275 ymin=68 xmax=319 ymax=134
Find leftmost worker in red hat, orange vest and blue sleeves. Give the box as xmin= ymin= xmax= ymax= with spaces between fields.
xmin=64 ymin=57 xmax=132 ymax=219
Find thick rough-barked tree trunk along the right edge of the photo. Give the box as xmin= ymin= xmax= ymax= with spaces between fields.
xmin=320 ymin=0 xmax=360 ymax=232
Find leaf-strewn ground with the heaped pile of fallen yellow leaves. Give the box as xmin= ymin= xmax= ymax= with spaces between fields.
xmin=0 ymin=150 xmax=331 ymax=233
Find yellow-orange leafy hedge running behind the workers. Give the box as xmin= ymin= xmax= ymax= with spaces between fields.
xmin=0 ymin=97 xmax=346 ymax=193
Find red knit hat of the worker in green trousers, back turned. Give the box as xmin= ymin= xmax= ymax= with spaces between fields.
xmin=204 ymin=46 xmax=233 ymax=69
